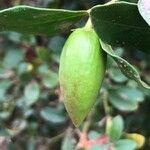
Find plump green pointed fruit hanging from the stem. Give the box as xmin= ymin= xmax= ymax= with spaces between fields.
xmin=59 ymin=28 xmax=106 ymax=127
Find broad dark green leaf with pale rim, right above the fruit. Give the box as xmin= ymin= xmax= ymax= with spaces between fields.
xmin=90 ymin=1 xmax=150 ymax=53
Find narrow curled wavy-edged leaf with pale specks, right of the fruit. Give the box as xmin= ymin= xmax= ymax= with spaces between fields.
xmin=101 ymin=40 xmax=150 ymax=90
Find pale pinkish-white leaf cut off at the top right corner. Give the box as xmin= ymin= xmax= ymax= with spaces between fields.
xmin=138 ymin=0 xmax=150 ymax=25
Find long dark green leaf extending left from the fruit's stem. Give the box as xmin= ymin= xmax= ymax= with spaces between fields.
xmin=0 ymin=6 xmax=87 ymax=35
